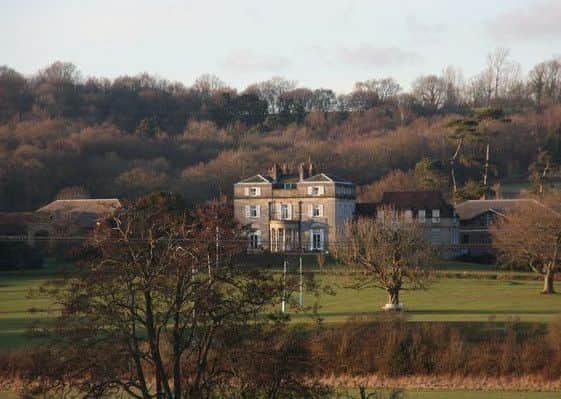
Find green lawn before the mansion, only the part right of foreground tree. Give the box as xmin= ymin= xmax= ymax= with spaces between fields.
xmin=297 ymin=276 xmax=561 ymax=322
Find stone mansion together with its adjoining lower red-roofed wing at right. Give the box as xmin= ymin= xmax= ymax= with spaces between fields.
xmin=234 ymin=162 xmax=459 ymax=258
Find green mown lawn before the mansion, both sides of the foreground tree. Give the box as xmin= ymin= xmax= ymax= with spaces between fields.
xmin=0 ymin=263 xmax=561 ymax=350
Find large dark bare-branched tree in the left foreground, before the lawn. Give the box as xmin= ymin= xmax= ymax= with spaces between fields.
xmin=29 ymin=193 xmax=324 ymax=399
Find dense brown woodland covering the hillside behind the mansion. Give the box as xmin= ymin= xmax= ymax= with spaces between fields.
xmin=0 ymin=49 xmax=561 ymax=211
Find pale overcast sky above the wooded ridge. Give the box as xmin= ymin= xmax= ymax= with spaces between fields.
xmin=0 ymin=0 xmax=561 ymax=92
